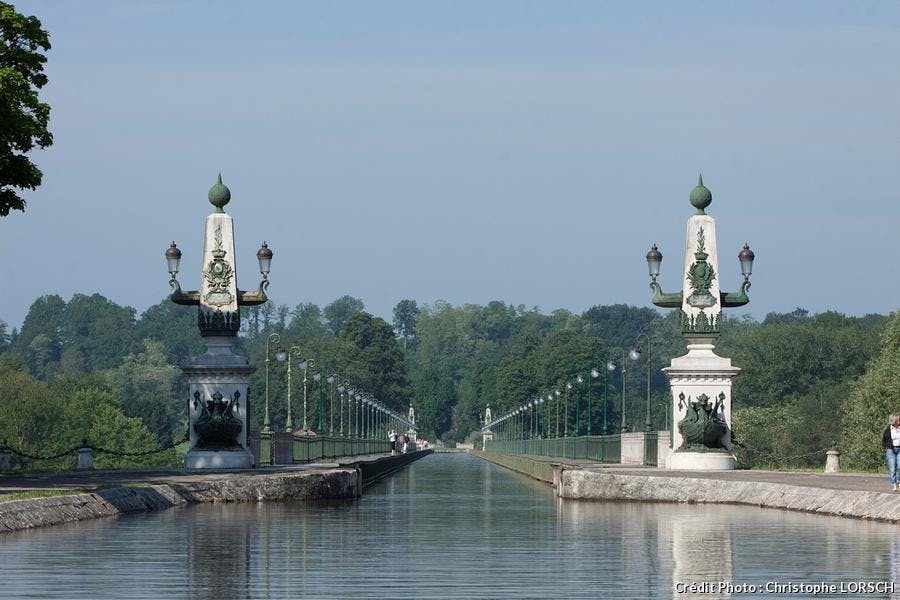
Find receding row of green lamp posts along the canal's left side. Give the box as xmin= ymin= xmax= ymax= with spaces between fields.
xmin=263 ymin=333 xmax=412 ymax=438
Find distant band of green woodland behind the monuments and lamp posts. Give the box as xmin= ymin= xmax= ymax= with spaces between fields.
xmin=0 ymin=294 xmax=900 ymax=468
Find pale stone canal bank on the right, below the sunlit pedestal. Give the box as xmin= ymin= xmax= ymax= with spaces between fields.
xmin=472 ymin=452 xmax=900 ymax=523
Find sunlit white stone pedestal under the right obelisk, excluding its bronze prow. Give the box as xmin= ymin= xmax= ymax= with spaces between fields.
xmin=663 ymin=337 xmax=740 ymax=471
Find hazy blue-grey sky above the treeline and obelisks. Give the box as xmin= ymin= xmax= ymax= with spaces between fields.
xmin=0 ymin=0 xmax=900 ymax=326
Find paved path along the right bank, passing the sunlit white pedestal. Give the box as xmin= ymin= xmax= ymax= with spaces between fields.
xmin=486 ymin=455 xmax=900 ymax=496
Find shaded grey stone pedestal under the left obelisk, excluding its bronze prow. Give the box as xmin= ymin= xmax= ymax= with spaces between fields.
xmin=182 ymin=336 xmax=256 ymax=469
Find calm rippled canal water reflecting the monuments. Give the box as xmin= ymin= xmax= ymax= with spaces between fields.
xmin=0 ymin=454 xmax=900 ymax=600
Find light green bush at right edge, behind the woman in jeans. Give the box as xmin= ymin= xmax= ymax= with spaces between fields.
xmin=841 ymin=313 xmax=900 ymax=469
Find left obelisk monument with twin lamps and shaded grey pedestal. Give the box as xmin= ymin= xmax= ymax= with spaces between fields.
xmin=166 ymin=175 xmax=272 ymax=469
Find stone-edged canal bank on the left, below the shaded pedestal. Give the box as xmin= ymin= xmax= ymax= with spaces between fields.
xmin=0 ymin=450 xmax=430 ymax=533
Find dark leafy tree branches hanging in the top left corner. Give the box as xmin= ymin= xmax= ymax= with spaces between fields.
xmin=0 ymin=2 xmax=53 ymax=217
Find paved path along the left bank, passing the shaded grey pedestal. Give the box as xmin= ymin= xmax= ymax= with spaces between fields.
xmin=0 ymin=454 xmax=388 ymax=494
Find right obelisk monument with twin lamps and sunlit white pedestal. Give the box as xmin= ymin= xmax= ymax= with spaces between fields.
xmin=647 ymin=177 xmax=754 ymax=470
